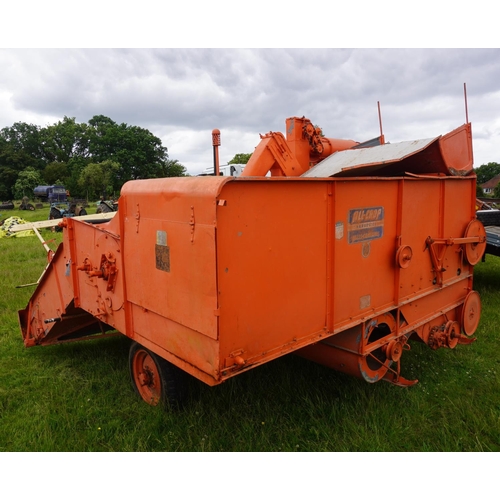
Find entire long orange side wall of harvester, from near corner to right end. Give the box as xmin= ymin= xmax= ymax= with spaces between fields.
xmin=217 ymin=177 xmax=475 ymax=376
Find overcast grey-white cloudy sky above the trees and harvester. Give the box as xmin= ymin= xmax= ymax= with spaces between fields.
xmin=0 ymin=48 xmax=500 ymax=174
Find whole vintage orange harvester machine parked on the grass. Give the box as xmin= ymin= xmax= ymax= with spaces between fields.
xmin=19 ymin=118 xmax=486 ymax=404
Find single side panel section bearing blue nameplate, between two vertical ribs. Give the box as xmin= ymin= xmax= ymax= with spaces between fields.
xmin=333 ymin=179 xmax=398 ymax=330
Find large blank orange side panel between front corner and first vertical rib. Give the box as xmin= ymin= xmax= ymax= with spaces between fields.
xmin=217 ymin=180 xmax=327 ymax=368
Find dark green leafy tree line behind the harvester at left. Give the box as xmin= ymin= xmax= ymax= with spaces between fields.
xmin=0 ymin=115 xmax=187 ymax=200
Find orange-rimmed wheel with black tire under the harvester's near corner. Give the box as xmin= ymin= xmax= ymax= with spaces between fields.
xmin=129 ymin=342 xmax=185 ymax=407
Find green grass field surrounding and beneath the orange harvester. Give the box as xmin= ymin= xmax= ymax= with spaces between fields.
xmin=0 ymin=203 xmax=500 ymax=454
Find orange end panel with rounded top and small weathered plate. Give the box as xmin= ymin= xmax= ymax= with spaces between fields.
xmin=120 ymin=177 xmax=226 ymax=339
